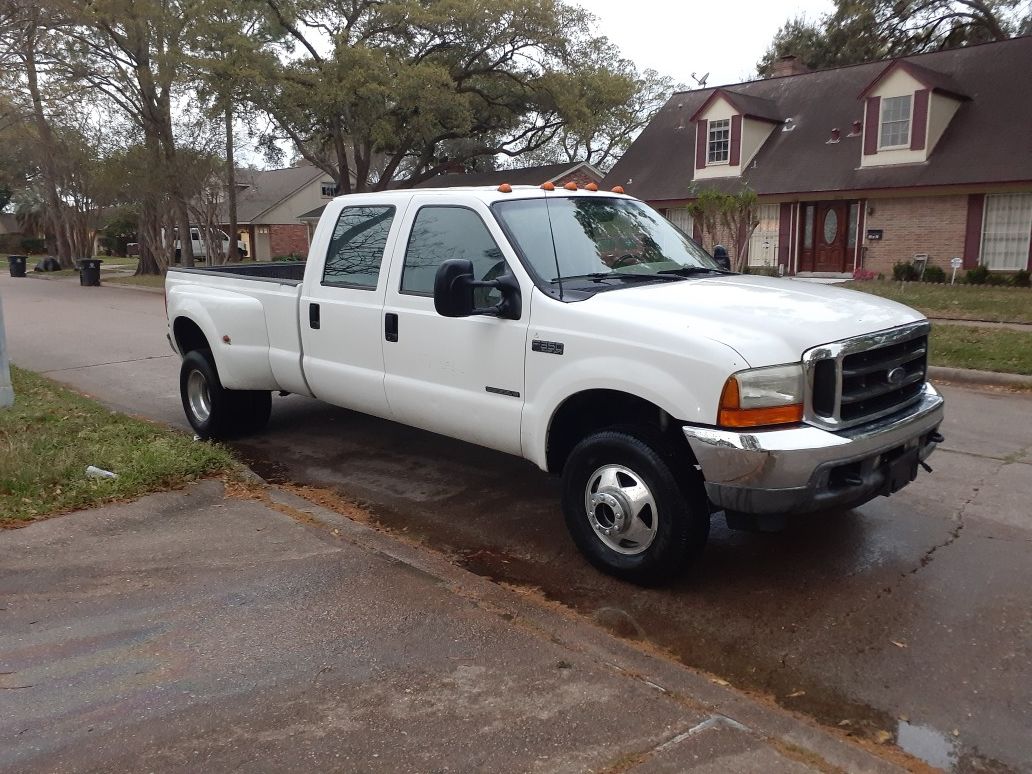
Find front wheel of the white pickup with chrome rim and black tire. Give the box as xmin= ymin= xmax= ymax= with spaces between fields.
xmin=562 ymin=428 xmax=710 ymax=585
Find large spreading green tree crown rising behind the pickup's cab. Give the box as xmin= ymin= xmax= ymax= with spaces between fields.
xmin=250 ymin=0 xmax=635 ymax=193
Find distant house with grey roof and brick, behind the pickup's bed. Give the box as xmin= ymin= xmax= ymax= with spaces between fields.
xmin=222 ymin=163 xmax=336 ymax=261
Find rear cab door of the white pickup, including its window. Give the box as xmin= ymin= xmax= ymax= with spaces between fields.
xmin=300 ymin=202 xmax=401 ymax=417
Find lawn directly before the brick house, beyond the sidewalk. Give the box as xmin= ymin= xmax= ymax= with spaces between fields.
xmin=839 ymin=280 xmax=1032 ymax=323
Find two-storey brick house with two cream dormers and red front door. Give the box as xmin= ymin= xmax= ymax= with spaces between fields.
xmin=605 ymin=37 xmax=1032 ymax=276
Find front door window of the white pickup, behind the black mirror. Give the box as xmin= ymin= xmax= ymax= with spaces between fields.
xmin=401 ymin=206 xmax=506 ymax=297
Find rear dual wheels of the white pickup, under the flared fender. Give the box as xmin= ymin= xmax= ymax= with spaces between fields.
xmin=180 ymin=350 xmax=272 ymax=439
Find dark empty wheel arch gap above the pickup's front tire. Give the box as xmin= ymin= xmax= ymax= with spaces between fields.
xmin=546 ymin=390 xmax=691 ymax=474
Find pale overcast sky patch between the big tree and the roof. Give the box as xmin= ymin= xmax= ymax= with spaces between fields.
xmin=572 ymin=0 xmax=834 ymax=87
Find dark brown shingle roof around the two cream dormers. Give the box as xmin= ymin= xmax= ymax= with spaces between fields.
xmin=604 ymin=37 xmax=1032 ymax=201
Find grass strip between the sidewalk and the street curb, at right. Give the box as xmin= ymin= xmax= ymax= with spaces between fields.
xmin=929 ymin=323 xmax=1032 ymax=376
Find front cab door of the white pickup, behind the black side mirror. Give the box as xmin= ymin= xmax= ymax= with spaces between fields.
xmin=384 ymin=195 xmax=530 ymax=454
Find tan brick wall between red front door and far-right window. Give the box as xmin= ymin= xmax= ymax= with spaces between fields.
xmin=864 ymin=196 xmax=967 ymax=276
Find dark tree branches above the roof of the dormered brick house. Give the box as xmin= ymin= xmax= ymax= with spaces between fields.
xmin=756 ymin=0 xmax=1032 ymax=75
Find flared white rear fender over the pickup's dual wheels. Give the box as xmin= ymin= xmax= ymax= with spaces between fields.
xmin=167 ymin=285 xmax=279 ymax=390
